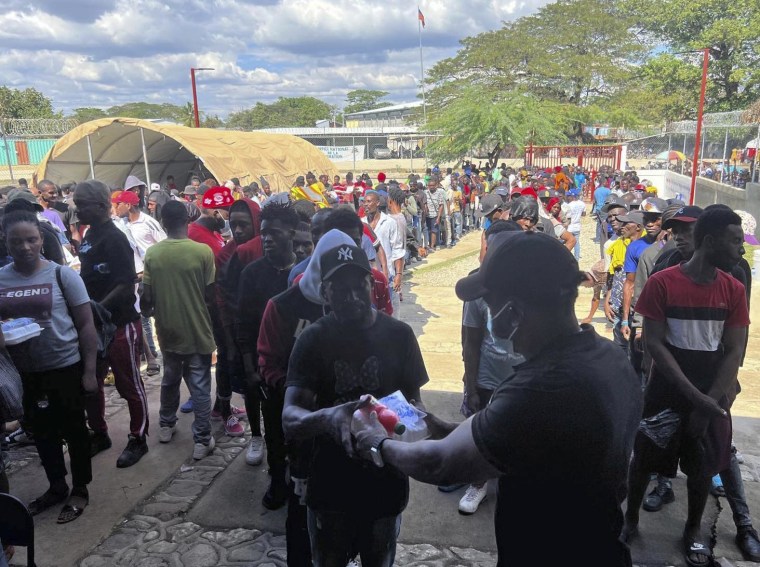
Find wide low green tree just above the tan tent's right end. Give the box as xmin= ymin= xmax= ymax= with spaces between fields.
xmin=227 ymin=96 xmax=335 ymax=130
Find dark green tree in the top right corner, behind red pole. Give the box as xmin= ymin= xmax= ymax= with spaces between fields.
xmin=623 ymin=0 xmax=760 ymax=113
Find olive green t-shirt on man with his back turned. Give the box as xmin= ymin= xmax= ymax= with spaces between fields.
xmin=143 ymin=238 xmax=216 ymax=354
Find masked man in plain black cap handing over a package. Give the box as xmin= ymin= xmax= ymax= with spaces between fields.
xmin=354 ymin=232 xmax=641 ymax=567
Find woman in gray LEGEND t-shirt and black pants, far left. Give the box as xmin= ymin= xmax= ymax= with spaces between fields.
xmin=0 ymin=211 xmax=98 ymax=524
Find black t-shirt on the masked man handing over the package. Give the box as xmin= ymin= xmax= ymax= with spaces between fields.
xmin=472 ymin=325 xmax=642 ymax=567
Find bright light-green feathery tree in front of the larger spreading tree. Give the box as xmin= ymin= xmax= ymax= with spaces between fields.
xmin=427 ymin=86 xmax=572 ymax=165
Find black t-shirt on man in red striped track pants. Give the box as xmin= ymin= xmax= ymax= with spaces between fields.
xmin=79 ymin=220 xmax=140 ymax=327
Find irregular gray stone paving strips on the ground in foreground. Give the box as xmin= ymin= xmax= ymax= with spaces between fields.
xmin=71 ymin=412 xmax=496 ymax=567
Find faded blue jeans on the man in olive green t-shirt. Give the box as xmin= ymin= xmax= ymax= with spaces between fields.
xmin=158 ymin=352 xmax=211 ymax=445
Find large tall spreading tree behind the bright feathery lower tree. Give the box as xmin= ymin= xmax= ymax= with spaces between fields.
xmin=426 ymin=0 xmax=644 ymax=124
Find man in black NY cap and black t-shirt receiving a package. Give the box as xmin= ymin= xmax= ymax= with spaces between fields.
xmin=282 ymin=244 xmax=428 ymax=567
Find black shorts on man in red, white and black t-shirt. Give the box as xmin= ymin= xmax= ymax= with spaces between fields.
xmin=633 ymin=412 xmax=733 ymax=478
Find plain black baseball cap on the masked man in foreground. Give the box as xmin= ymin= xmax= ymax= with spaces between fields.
xmin=456 ymin=231 xmax=581 ymax=301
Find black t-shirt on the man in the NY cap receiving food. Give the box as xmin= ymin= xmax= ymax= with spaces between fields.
xmin=286 ymin=313 xmax=428 ymax=518
